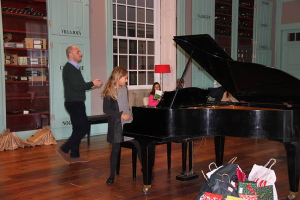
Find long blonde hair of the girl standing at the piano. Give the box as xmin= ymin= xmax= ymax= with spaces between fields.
xmin=101 ymin=66 xmax=128 ymax=100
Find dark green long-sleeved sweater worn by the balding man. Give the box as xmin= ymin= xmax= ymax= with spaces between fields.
xmin=62 ymin=62 xmax=94 ymax=102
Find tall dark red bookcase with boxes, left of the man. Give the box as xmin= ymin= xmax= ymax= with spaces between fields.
xmin=1 ymin=0 xmax=50 ymax=131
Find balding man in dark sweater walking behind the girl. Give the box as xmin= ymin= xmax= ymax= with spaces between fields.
xmin=56 ymin=46 xmax=102 ymax=164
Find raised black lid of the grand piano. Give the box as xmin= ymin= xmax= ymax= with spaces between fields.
xmin=174 ymin=34 xmax=300 ymax=104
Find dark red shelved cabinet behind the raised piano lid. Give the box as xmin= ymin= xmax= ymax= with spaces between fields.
xmin=215 ymin=0 xmax=254 ymax=62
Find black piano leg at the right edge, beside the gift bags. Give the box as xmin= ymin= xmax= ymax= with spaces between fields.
xmin=284 ymin=142 xmax=300 ymax=199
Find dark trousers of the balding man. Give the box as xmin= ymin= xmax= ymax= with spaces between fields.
xmin=61 ymin=102 xmax=90 ymax=158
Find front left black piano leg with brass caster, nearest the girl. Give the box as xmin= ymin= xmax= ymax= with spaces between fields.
xmin=138 ymin=140 xmax=155 ymax=194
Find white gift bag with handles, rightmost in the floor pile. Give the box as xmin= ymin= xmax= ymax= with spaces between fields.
xmin=248 ymin=158 xmax=278 ymax=200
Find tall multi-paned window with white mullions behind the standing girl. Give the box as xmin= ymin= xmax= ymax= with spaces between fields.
xmin=112 ymin=0 xmax=159 ymax=86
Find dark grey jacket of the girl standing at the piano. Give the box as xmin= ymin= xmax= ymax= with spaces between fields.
xmin=103 ymin=96 xmax=124 ymax=143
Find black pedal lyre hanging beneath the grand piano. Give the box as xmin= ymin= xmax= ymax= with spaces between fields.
xmin=176 ymin=141 xmax=199 ymax=181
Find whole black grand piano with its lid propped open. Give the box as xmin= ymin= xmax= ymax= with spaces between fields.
xmin=124 ymin=35 xmax=300 ymax=198
